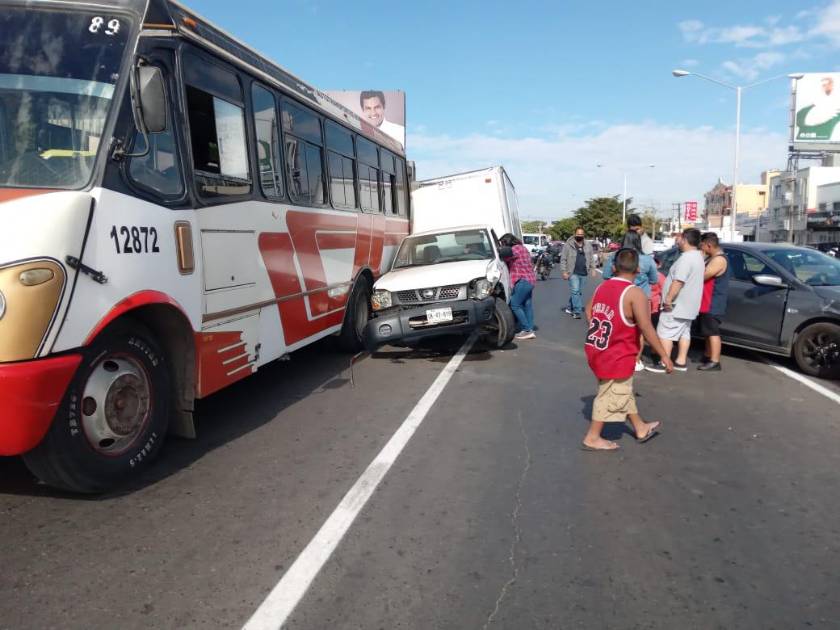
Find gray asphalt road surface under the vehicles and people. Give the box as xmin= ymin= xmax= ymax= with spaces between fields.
xmin=0 ymin=278 xmax=840 ymax=630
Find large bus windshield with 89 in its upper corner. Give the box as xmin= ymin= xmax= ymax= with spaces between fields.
xmin=0 ymin=8 xmax=132 ymax=188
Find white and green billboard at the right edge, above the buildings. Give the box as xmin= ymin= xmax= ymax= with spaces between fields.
xmin=793 ymin=72 xmax=840 ymax=151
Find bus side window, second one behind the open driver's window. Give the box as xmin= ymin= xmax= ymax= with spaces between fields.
xmin=281 ymin=100 xmax=327 ymax=206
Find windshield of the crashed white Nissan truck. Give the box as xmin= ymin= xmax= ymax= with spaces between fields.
xmin=394 ymin=230 xmax=495 ymax=269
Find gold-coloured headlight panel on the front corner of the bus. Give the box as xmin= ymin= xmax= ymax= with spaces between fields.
xmin=0 ymin=260 xmax=65 ymax=362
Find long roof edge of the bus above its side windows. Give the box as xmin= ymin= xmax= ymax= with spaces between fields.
xmin=143 ymin=0 xmax=405 ymax=157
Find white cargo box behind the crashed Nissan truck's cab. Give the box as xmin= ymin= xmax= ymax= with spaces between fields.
xmin=411 ymin=166 xmax=522 ymax=238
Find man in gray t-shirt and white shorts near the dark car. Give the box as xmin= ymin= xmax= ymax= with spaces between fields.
xmin=647 ymin=228 xmax=705 ymax=373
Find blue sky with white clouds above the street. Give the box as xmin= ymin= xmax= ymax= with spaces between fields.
xmin=187 ymin=0 xmax=840 ymax=219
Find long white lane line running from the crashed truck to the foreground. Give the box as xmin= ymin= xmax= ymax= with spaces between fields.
xmin=243 ymin=334 xmax=476 ymax=630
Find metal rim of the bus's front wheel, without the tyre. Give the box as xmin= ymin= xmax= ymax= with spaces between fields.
xmin=80 ymin=355 xmax=152 ymax=456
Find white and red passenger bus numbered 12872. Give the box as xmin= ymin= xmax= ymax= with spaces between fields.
xmin=0 ymin=0 xmax=410 ymax=492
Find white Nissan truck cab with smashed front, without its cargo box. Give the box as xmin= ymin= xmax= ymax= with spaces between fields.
xmin=365 ymin=226 xmax=516 ymax=351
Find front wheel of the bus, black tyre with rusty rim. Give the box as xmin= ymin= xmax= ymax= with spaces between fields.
xmin=23 ymin=323 xmax=171 ymax=493
